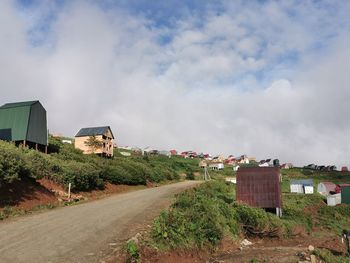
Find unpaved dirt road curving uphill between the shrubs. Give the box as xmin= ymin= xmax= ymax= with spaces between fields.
xmin=0 ymin=181 xmax=198 ymax=263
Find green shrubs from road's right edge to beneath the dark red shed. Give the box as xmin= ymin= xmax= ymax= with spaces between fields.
xmin=152 ymin=181 xmax=284 ymax=249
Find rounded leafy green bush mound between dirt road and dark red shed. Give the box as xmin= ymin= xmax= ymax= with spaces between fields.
xmin=152 ymin=183 xmax=239 ymax=248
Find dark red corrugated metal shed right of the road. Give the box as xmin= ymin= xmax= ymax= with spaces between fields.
xmin=236 ymin=167 xmax=282 ymax=208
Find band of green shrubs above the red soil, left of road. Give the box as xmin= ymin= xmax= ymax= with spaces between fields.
xmin=0 ymin=137 xmax=198 ymax=191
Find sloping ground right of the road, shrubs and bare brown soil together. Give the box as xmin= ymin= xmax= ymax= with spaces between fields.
xmin=122 ymin=168 xmax=350 ymax=263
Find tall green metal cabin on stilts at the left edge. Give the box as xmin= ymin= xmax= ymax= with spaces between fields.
xmin=0 ymin=100 xmax=48 ymax=152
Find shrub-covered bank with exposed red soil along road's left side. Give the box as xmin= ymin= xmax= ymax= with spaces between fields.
xmin=0 ymin=137 xmax=198 ymax=218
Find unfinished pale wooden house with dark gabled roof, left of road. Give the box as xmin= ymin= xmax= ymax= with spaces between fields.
xmin=74 ymin=126 xmax=114 ymax=157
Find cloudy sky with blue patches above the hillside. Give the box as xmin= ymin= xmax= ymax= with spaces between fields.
xmin=0 ymin=0 xmax=350 ymax=166
